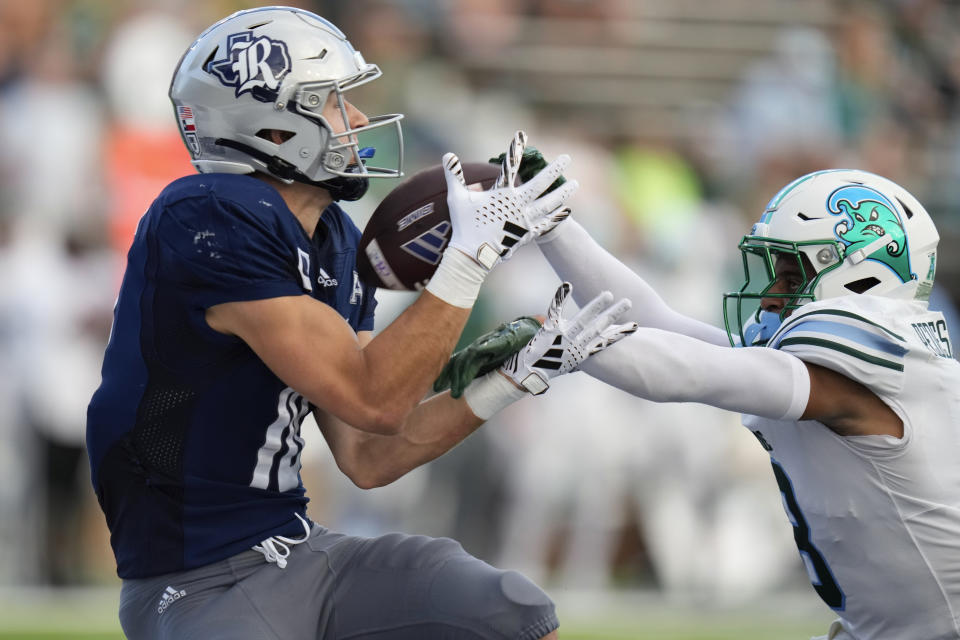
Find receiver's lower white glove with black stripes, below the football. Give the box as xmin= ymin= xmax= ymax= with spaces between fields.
xmin=500 ymin=282 xmax=638 ymax=395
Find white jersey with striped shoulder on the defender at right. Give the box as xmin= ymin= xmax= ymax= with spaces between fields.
xmin=743 ymin=296 xmax=960 ymax=640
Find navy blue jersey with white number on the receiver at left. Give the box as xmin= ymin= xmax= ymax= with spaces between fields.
xmin=87 ymin=174 xmax=376 ymax=578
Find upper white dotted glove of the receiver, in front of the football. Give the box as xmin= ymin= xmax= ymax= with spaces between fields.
xmin=443 ymin=131 xmax=579 ymax=270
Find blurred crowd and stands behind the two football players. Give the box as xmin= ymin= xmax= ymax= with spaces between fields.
xmin=0 ymin=0 xmax=960 ymax=602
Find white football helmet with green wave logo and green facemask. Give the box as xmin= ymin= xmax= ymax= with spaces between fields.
xmin=723 ymin=169 xmax=940 ymax=344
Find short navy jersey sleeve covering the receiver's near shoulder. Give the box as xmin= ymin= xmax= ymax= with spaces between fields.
xmin=156 ymin=196 xmax=303 ymax=307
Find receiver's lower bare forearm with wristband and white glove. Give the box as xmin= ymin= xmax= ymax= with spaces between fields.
xmin=317 ymin=283 xmax=636 ymax=488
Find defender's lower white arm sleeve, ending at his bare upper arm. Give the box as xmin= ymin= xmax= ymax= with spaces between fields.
xmin=581 ymin=329 xmax=810 ymax=420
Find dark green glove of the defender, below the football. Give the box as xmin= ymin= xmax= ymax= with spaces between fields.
xmin=433 ymin=316 xmax=540 ymax=398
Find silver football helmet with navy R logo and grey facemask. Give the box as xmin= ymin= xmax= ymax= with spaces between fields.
xmin=170 ymin=7 xmax=403 ymax=200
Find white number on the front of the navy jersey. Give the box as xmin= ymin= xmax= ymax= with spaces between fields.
xmin=250 ymin=387 xmax=310 ymax=491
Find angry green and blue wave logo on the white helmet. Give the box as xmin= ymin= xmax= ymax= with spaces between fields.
xmin=827 ymin=185 xmax=914 ymax=282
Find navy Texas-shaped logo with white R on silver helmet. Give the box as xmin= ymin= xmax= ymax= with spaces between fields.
xmin=206 ymin=31 xmax=290 ymax=102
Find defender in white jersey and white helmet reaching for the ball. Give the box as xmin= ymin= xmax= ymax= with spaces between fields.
xmin=524 ymin=170 xmax=960 ymax=640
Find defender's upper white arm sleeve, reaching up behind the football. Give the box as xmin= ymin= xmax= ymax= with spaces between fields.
xmin=538 ymin=220 xmax=730 ymax=346
